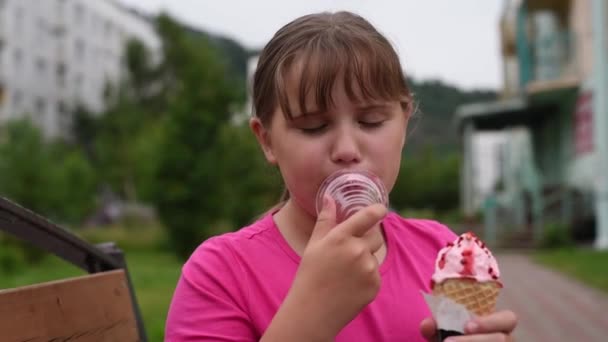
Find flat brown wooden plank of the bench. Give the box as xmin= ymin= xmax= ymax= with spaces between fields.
xmin=0 ymin=270 xmax=139 ymax=342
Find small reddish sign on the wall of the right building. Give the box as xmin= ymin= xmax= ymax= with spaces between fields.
xmin=574 ymin=90 xmax=593 ymax=155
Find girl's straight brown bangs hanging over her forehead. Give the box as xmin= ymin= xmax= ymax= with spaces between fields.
xmin=275 ymin=30 xmax=410 ymax=119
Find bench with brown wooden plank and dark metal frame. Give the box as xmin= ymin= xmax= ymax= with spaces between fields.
xmin=0 ymin=197 xmax=147 ymax=342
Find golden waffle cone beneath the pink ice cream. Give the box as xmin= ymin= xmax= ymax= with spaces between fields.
xmin=433 ymin=278 xmax=501 ymax=316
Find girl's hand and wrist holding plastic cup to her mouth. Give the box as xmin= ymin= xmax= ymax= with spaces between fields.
xmin=269 ymin=196 xmax=387 ymax=341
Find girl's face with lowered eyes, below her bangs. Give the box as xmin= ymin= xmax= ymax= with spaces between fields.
xmin=251 ymin=76 xmax=409 ymax=217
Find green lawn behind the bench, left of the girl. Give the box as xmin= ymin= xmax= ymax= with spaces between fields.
xmin=0 ymin=227 xmax=182 ymax=341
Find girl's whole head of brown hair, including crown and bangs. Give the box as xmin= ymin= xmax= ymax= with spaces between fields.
xmin=252 ymin=12 xmax=412 ymax=203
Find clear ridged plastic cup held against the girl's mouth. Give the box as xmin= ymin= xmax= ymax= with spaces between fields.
xmin=316 ymin=171 xmax=388 ymax=222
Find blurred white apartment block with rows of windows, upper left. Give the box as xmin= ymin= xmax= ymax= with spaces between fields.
xmin=0 ymin=0 xmax=161 ymax=136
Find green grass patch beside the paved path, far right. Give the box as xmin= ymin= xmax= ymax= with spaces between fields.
xmin=533 ymin=248 xmax=608 ymax=293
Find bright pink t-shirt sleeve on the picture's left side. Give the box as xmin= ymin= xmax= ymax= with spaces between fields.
xmin=165 ymin=237 xmax=257 ymax=342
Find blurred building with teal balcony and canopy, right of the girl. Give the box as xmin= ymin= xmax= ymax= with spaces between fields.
xmin=456 ymin=0 xmax=608 ymax=247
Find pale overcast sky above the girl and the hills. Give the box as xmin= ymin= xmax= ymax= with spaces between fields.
xmin=118 ymin=0 xmax=506 ymax=90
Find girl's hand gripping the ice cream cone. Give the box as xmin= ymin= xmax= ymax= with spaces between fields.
xmin=420 ymin=310 xmax=517 ymax=342
